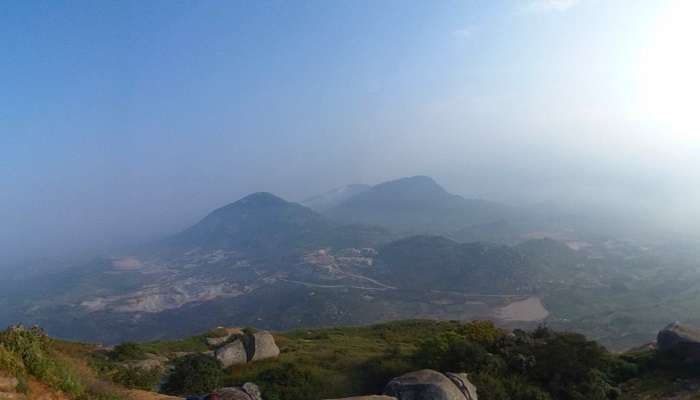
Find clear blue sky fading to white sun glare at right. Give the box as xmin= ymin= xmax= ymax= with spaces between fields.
xmin=0 ymin=0 xmax=700 ymax=264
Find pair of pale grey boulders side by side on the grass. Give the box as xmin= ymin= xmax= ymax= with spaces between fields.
xmin=209 ymin=331 xmax=280 ymax=368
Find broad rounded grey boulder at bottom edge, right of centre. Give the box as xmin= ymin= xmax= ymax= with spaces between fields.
xmin=384 ymin=369 xmax=477 ymax=400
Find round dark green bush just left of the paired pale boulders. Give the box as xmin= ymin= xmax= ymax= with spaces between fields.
xmin=163 ymin=354 xmax=224 ymax=395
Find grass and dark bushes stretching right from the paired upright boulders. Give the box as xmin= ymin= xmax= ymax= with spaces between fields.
xmin=223 ymin=320 xmax=636 ymax=400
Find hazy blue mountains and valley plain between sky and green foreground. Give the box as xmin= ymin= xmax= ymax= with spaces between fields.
xmin=0 ymin=177 xmax=700 ymax=350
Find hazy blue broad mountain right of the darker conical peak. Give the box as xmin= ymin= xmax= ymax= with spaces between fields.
xmin=324 ymin=176 xmax=516 ymax=233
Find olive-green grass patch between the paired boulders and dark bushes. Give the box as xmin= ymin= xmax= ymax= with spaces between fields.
xmin=228 ymin=320 xmax=463 ymax=398
